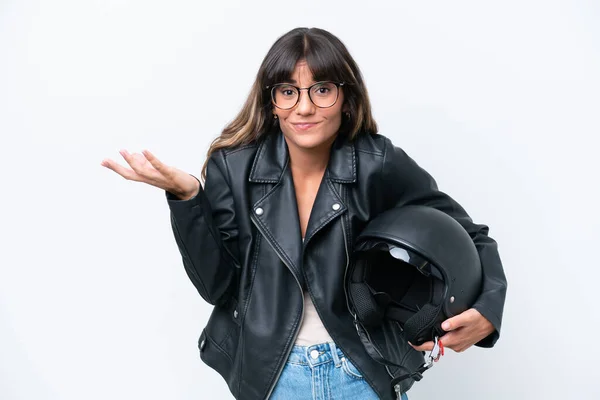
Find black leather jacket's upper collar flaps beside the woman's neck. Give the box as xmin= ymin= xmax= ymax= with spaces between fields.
xmin=249 ymin=129 xmax=356 ymax=183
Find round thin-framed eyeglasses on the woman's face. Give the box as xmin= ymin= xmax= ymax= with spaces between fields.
xmin=265 ymin=81 xmax=344 ymax=110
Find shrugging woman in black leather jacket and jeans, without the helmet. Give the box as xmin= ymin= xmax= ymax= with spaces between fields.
xmin=102 ymin=28 xmax=506 ymax=400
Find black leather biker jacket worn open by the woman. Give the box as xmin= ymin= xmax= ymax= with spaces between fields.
xmin=166 ymin=132 xmax=506 ymax=400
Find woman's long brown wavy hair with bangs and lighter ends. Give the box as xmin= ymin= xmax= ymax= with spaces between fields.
xmin=202 ymin=28 xmax=377 ymax=180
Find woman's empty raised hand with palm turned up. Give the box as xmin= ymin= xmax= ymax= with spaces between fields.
xmin=100 ymin=150 xmax=200 ymax=200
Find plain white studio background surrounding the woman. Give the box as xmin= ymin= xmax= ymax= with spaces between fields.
xmin=0 ymin=0 xmax=600 ymax=400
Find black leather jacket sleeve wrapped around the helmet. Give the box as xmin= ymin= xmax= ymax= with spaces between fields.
xmin=382 ymin=138 xmax=507 ymax=347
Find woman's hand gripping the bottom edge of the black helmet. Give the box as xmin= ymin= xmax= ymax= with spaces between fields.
xmin=410 ymin=308 xmax=494 ymax=353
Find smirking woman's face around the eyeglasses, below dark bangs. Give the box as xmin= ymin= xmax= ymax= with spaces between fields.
xmin=273 ymin=60 xmax=344 ymax=150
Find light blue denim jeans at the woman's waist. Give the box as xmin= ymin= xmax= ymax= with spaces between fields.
xmin=269 ymin=342 xmax=408 ymax=400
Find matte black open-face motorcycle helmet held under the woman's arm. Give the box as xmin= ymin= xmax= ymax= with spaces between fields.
xmin=346 ymin=206 xmax=482 ymax=394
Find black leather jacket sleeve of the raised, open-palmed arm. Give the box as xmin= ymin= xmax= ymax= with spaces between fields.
xmin=166 ymin=152 xmax=239 ymax=305
